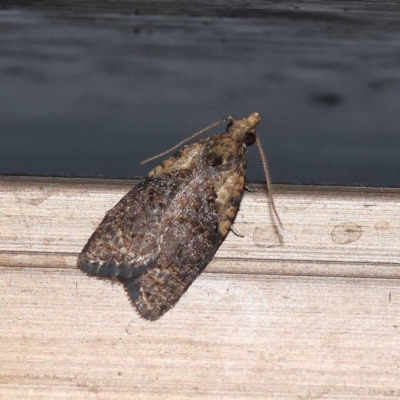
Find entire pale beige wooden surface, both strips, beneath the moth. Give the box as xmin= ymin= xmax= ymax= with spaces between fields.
xmin=0 ymin=178 xmax=400 ymax=399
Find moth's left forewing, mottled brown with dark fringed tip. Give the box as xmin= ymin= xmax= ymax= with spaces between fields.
xmin=78 ymin=144 xmax=200 ymax=278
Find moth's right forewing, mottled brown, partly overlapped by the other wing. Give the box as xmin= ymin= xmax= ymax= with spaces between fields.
xmin=122 ymin=164 xmax=244 ymax=320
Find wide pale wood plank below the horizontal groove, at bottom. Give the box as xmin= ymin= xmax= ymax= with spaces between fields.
xmin=0 ymin=268 xmax=400 ymax=399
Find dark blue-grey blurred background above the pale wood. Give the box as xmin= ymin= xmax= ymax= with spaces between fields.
xmin=0 ymin=0 xmax=400 ymax=186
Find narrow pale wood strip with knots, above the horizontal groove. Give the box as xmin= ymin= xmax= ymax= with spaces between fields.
xmin=0 ymin=178 xmax=400 ymax=277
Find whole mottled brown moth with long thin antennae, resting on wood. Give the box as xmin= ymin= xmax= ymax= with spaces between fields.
xmin=78 ymin=113 xmax=280 ymax=321
